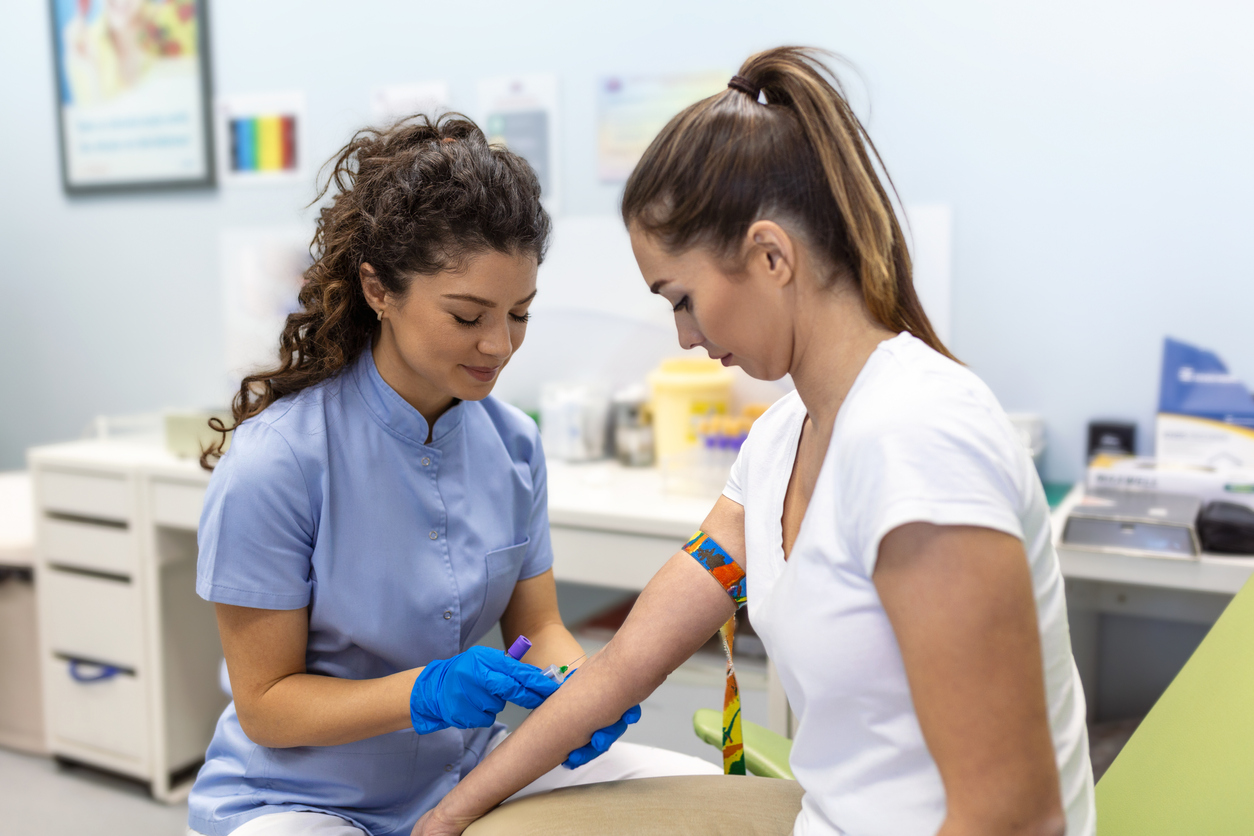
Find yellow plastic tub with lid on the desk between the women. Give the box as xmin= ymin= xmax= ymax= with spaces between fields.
xmin=648 ymin=357 xmax=732 ymax=462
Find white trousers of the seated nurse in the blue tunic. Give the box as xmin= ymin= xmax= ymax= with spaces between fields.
xmin=187 ymin=734 xmax=722 ymax=836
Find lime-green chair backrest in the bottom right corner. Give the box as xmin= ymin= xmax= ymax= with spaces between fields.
xmin=1097 ymin=582 xmax=1254 ymax=836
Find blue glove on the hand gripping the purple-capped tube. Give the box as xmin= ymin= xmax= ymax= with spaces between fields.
xmin=409 ymin=645 xmax=558 ymax=734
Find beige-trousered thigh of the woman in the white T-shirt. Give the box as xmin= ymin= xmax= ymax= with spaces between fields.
xmin=465 ymin=775 xmax=803 ymax=836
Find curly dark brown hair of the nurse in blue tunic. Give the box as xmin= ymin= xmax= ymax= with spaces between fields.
xmin=201 ymin=113 xmax=551 ymax=470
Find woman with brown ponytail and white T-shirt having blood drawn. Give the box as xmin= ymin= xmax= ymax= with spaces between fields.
xmin=414 ymin=48 xmax=1095 ymax=836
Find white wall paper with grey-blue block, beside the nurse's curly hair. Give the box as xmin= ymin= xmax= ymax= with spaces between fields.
xmin=479 ymin=73 xmax=562 ymax=213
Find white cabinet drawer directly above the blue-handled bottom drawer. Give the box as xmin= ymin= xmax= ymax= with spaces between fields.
xmin=39 ymin=569 xmax=143 ymax=668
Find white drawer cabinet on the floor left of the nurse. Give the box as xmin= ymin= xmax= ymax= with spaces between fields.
xmin=29 ymin=441 xmax=227 ymax=801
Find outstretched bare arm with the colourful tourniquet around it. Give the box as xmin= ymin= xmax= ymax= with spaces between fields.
xmin=414 ymin=496 xmax=745 ymax=836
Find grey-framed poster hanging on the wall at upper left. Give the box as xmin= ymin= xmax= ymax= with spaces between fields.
xmin=49 ymin=0 xmax=214 ymax=194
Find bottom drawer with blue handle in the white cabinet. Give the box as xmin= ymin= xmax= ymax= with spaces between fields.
xmin=45 ymin=657 xmax=148 ymax=762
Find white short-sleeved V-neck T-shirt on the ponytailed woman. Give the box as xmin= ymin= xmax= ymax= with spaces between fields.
xmin=724 ymin=333 xmax=1096 ymax=836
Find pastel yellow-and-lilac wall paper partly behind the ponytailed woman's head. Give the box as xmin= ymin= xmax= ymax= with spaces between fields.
xmin=597 ymin=71 xmax=731 ymax=183
